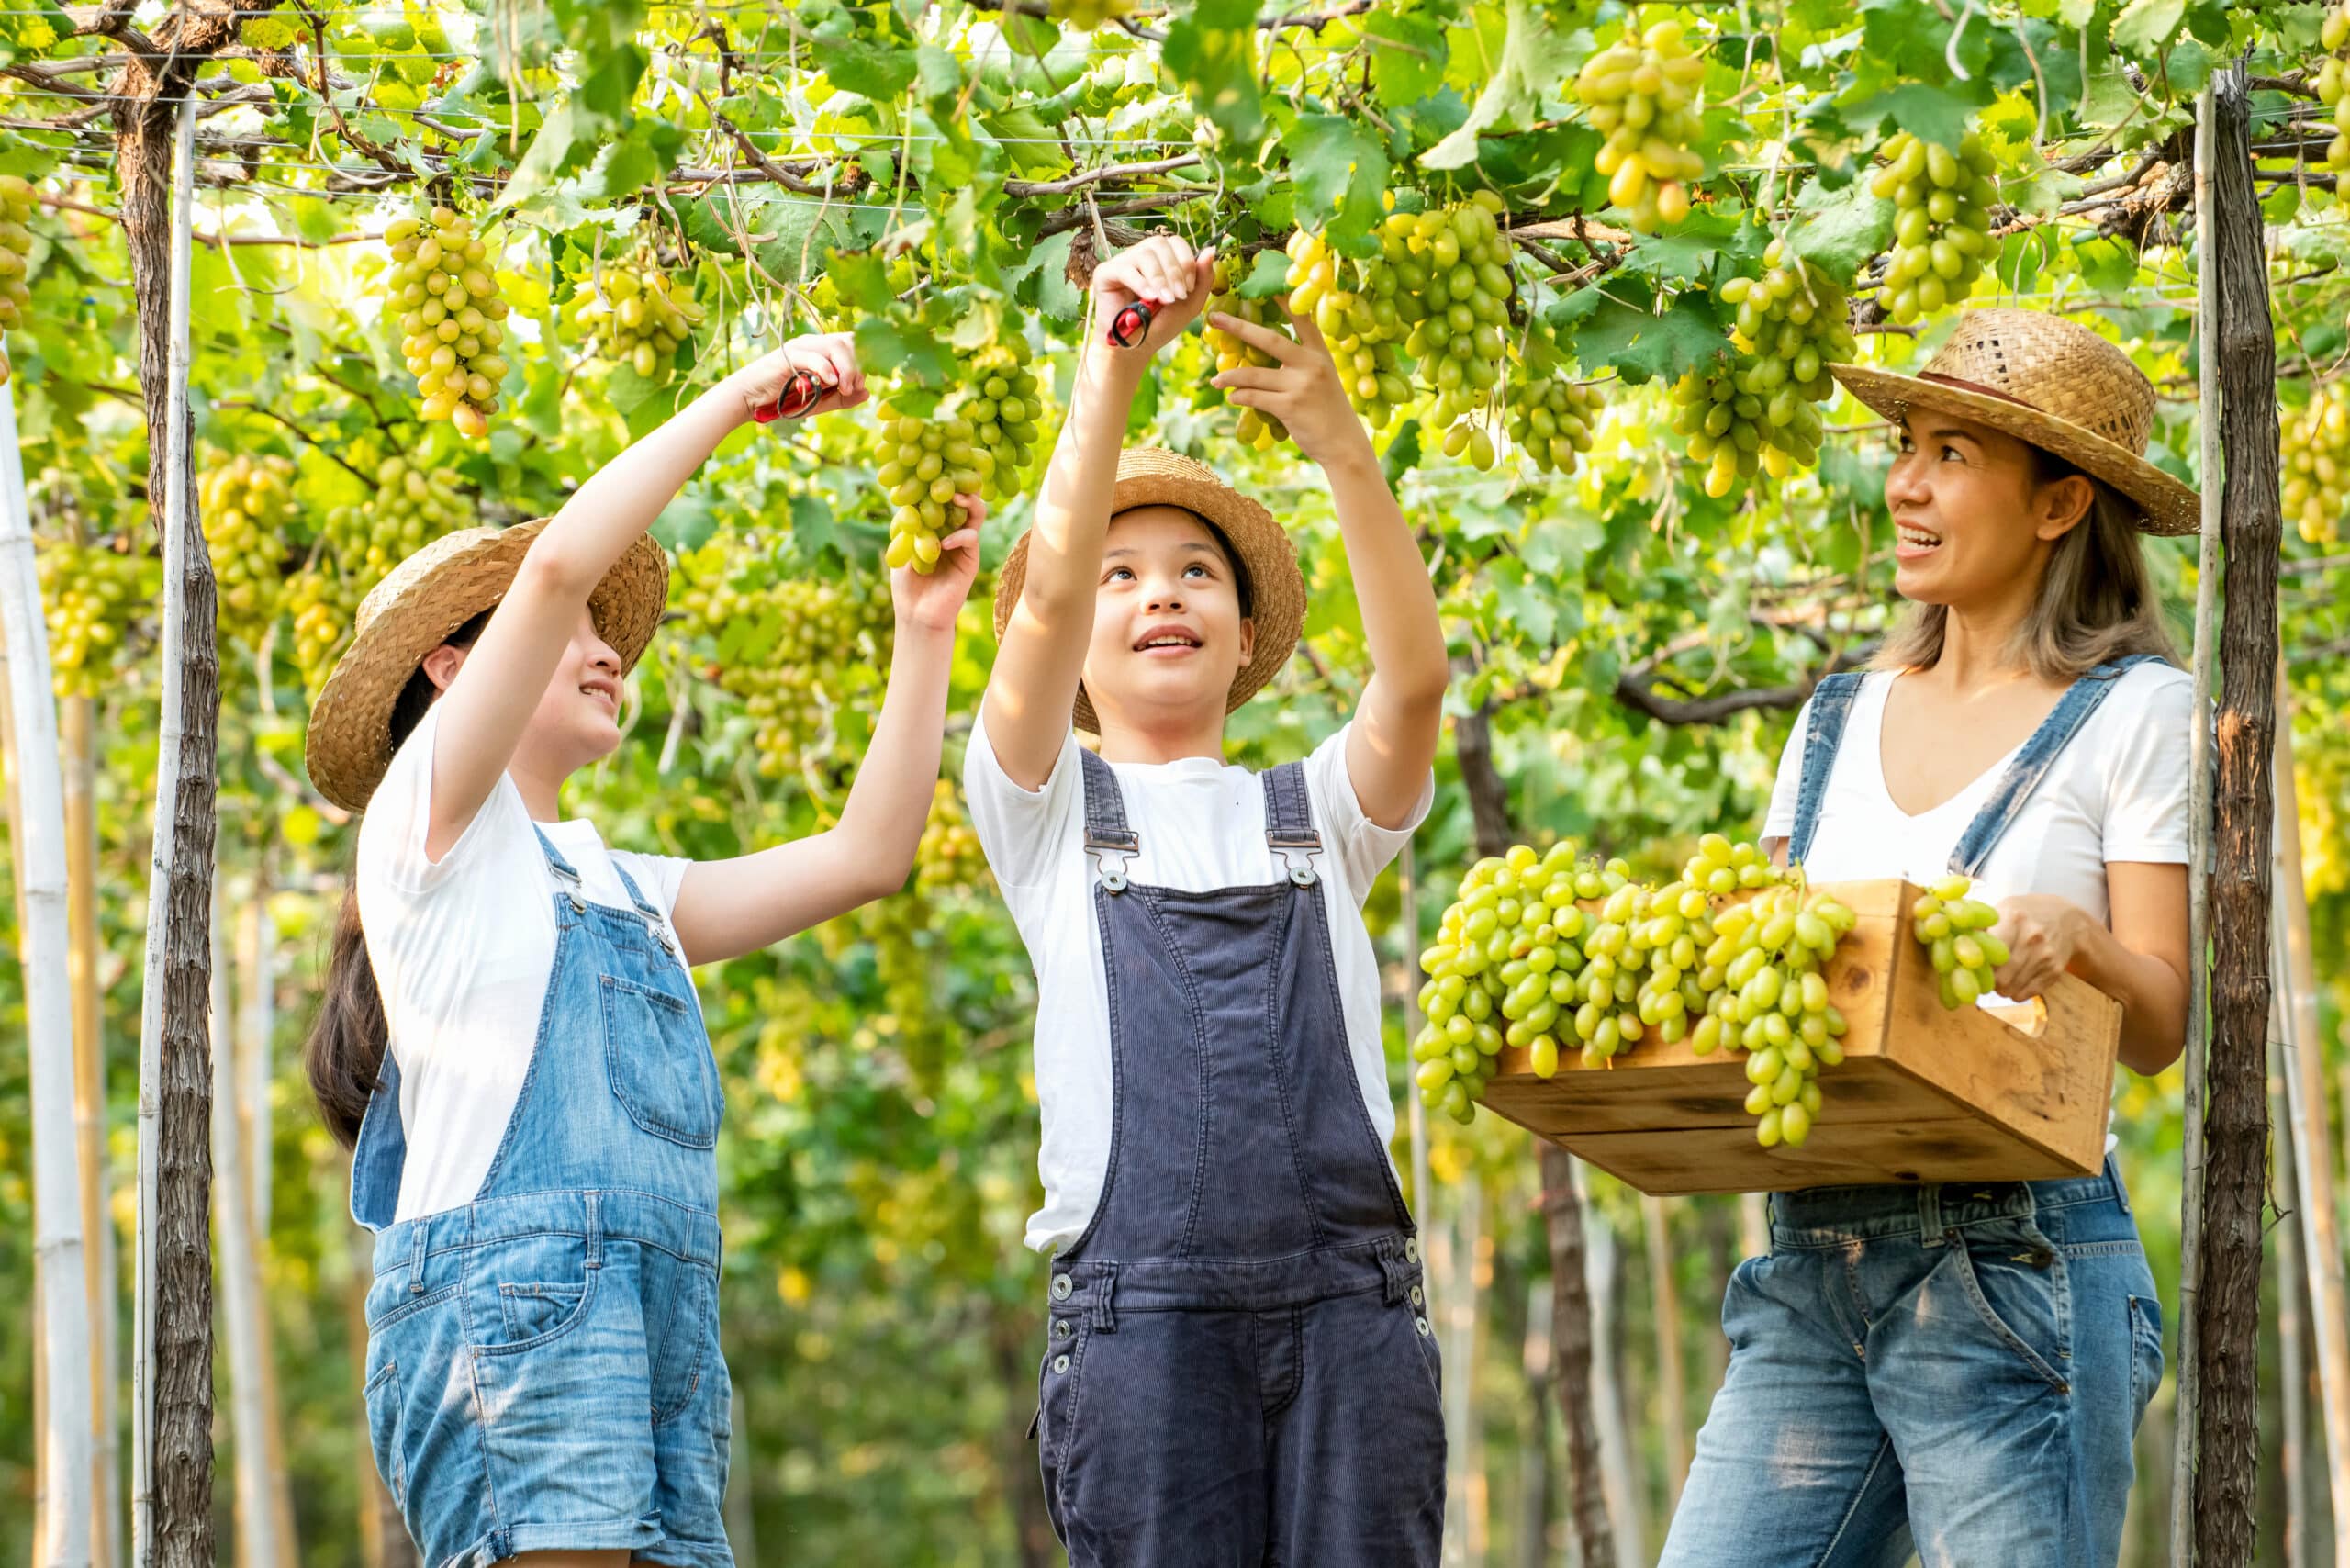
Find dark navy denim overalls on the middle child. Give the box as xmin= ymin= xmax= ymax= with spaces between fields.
xmin=1036 ymin=752 xmax=1445 ymax=1568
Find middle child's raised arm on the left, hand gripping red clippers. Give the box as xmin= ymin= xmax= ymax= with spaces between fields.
xmin=980 ymin=235 xmax=1213 ymax=790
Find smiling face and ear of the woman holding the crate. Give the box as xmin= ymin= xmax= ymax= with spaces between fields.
xmin=1885 ymin=409 xmax=2097 ymax=607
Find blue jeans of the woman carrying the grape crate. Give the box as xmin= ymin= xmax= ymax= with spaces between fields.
xmin=1659 ymin=1159 xmax=2162 ymax=1568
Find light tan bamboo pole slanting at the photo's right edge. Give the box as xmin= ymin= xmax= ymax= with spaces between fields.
xmin=2270 ymin=690 xmax=2350 ymax=1563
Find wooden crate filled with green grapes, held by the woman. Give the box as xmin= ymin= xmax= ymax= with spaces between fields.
xmin=1485 ymin=881 xmax=2122 ymax=1194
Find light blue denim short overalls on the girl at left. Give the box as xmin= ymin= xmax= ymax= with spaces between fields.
xmin=350 ymin=834 xmax=733 ymax=1568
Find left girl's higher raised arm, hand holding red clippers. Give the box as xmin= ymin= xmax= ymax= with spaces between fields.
xmin=425 ymin=336 xmax=865 ymax=858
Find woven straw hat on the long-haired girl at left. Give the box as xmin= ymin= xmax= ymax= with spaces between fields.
xmin=306 ymin=517 xmax=670 ymax=811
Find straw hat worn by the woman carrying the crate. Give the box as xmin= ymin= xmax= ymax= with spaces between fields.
xmin=1833 ymin=310 xmax=2202 ymax=533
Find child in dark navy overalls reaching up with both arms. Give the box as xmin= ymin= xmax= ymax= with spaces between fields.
xmin=966 ymin=238 xmax=1448 ymax=1568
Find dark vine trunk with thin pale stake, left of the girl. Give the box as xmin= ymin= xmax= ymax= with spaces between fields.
xmin=118 ymin=83 xmax=220 ymax=1568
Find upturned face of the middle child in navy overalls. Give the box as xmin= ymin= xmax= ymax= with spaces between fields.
xmin=1086 ymin=506 xmax=1255 ymax=724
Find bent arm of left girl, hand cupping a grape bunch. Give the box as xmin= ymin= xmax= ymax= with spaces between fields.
xmin=670 ymin=496 xmax=987 ymax=964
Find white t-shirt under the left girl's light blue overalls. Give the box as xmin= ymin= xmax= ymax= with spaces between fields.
xmin=355 ymin=708 xmax=693 ymax=1220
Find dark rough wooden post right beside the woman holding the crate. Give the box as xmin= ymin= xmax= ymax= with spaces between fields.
xmin=2195 ymin=66 xmax=2282 ymax=1568
